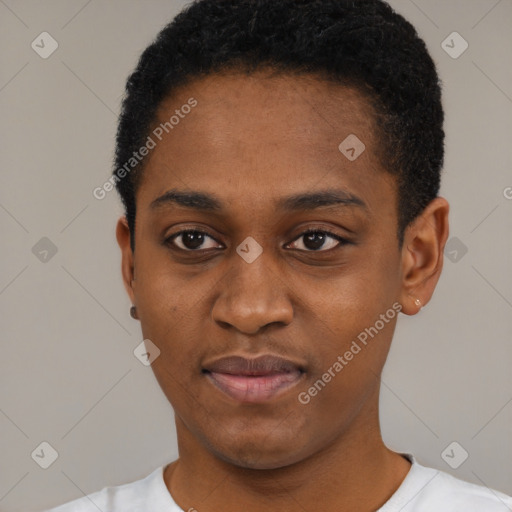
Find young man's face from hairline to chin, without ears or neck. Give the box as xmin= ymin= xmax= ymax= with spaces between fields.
xmin=132 ymin=70 xmax=401 ymax=468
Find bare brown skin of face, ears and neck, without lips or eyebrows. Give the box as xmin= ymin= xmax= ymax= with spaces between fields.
xmin=117 ymin=72 xmax=449 ymax=512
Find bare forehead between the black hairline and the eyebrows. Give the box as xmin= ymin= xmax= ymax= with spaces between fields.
xmin=135 ymin=72 xmax=389 ymax=215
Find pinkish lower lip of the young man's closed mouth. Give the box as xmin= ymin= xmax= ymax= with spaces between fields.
xmin=207 ymin=371 xmax=302 ymax=403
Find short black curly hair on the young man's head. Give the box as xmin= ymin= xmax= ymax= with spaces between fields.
xmin=114 ymin=0 xmax=444 ymax=250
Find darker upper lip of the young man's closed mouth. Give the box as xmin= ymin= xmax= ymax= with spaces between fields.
xmin=204 ymin=355 xmax=304 ymax=376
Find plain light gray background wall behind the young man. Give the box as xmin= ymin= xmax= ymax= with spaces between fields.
xmin=0 ymin=0 xmax=512 ymax=512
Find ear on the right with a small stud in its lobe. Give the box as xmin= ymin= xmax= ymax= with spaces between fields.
xmin=400 ymin=197 xmax=450 ymax=315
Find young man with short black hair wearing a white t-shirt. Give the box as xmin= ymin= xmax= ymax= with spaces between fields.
xmin=45 ymin=0 xmax=512 ymax=512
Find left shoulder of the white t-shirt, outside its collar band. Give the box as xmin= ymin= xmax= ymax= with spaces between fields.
xmin=43 ymin=467 xmax=163 ymax=512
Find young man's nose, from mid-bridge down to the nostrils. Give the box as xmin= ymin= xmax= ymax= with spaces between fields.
xmin=212 ymin=252 xmax=293 ymax=334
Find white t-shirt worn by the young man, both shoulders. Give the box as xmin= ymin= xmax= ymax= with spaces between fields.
xmin=41 ymin=453 xmax=512 ymax=512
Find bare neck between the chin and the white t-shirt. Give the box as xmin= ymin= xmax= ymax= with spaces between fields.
xmin=164 ymin=392 xmax=410 ymax=512
